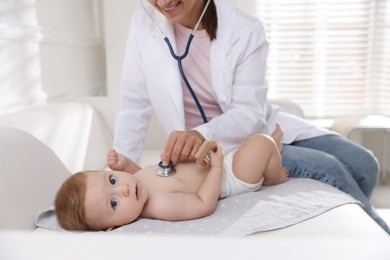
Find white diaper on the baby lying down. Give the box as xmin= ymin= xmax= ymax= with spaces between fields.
xmin=219 ymin=149 xmax=264 ymax=198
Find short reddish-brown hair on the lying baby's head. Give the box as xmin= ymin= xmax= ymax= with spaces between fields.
xmin=54 ymin=172 xmax=91 ymax=230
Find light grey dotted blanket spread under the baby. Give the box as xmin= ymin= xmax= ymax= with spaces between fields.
xmin=36 ymin=179 xmax=359 ymax=236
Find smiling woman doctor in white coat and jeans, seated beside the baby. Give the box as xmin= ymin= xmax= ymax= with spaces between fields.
xmin=114 ymin=0 xmax=388 ymax=234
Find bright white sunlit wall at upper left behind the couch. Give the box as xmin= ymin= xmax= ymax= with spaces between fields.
xmin=0 ymin=0 xmax=106 ymax=113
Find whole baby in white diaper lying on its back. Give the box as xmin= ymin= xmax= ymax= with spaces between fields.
xmin=55 ymin=125 xmax=288 ymax=231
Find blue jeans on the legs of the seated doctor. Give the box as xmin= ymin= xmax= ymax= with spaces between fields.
xmin=282 ymin=135 xmax=390 ymax=234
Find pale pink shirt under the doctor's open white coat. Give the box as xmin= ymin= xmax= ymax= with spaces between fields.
xmin=174 ymin=24 xmax=222 ymax=130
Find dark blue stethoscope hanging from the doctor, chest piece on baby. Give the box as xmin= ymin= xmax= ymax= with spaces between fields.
xmin=140 ymin=0 xmax=210 ymax=177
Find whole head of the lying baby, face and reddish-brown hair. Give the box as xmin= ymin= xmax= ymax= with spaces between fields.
xmin=55 ymin=171 xmax=148 ymax=230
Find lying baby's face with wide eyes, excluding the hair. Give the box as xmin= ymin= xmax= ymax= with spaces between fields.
xmin=84 ymin=171 xmax=148 ymax=230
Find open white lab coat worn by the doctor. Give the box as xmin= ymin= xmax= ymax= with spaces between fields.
xmin=114 ymin=0 xmax=326 ymax=162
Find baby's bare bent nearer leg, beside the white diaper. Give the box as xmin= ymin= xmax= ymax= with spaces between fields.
xmin=233 ymin=134 xmax=288 ymax=185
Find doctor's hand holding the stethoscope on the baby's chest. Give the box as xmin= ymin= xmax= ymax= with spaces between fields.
xmin=161 ymin=130 xmax=205 ymax=165
